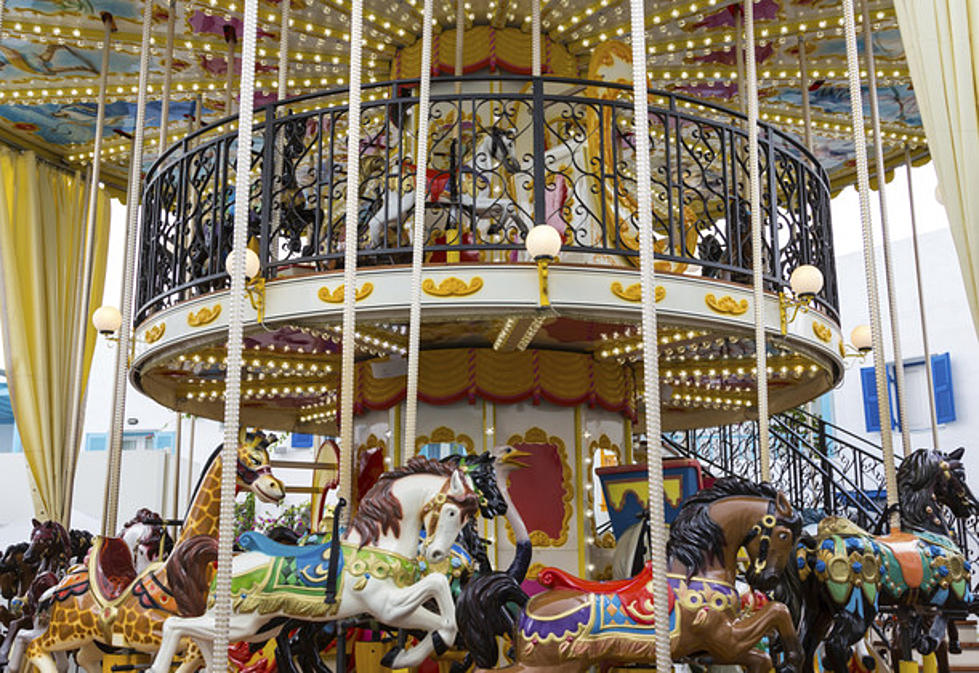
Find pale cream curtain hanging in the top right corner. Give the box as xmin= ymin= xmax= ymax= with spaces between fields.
xmin=894 ymin=0 xmax=979 ymax=333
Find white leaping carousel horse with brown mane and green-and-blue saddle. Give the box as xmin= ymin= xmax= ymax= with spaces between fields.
xmin=146 ymin=456 xmax=479 ymax=673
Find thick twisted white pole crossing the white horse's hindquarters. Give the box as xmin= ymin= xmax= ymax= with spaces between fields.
xmin=208 ymin=0 xmax=260 ymax=673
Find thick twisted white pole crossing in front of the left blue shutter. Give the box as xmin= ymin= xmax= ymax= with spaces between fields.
xmin=843 ymin=0 xmax=901 ymax=530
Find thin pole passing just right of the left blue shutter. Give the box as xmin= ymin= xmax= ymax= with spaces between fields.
xmin=863 ymin=0 xmax=912 ymax=456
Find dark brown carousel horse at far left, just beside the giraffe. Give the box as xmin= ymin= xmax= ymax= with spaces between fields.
xmin=0 ymin=519 xmax=71 ymax=667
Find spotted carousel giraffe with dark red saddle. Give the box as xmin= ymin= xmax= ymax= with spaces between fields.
xmin=12 ymin=433 xmax=285 ymax=673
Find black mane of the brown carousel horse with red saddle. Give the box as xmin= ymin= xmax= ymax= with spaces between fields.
xmin=666 ymin=477 xmax=778 ymax=574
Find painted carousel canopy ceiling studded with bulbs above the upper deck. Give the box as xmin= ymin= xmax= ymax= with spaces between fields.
xmin=0 ymin=0 xmax=927 ymax=188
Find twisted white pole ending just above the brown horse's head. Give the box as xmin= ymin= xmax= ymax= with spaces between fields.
xmin=744 ymin=0 xmax=772 ymax=481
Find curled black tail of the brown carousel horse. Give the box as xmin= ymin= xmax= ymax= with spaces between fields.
xmin=456 ymin=571 xmax=529 ymax=668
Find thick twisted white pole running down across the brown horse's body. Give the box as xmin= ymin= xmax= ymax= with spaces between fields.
xmin=628 ymin=0 xmax=671 ymax=671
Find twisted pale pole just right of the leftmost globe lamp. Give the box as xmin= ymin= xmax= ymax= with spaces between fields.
xmin=102 ymin=0 xmax=153 ymax=535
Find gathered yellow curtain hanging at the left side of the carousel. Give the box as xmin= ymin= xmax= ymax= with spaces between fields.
xmin=0 ymin=149 xmax=109 ymax=522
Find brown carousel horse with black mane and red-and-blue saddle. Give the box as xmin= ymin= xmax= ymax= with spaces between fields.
xmin=457 ymin=477 xmax=802 ymax=673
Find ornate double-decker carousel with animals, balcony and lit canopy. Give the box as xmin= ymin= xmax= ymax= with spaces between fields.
xmin=0 ymin=0 xmax=979 ymax=673
